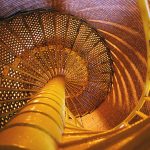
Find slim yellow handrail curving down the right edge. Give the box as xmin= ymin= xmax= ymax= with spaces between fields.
xmin=110 ymin=0 xmax=150 ymax=130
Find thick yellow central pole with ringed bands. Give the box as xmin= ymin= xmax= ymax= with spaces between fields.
xmin=0 ymin=77 xmax=65 ymax=150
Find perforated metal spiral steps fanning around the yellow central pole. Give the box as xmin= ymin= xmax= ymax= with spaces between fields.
xmin=0 ymin=10 xmax=112 ymax=127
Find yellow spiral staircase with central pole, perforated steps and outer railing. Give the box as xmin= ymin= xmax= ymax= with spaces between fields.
xmin=0 ymin=0 xmax=150 ymax=150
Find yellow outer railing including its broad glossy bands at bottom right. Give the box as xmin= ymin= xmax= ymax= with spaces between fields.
xmin=62 ymin=0 xmax=150 ymax=150
